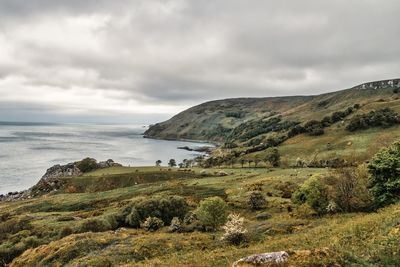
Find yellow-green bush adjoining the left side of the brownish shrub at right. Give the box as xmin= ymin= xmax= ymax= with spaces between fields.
xmin=293 ymin=176 xmax=329 ymax=215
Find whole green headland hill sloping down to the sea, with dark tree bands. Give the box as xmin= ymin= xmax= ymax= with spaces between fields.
xmin=145 ymin=79 xmax=400 ymax=165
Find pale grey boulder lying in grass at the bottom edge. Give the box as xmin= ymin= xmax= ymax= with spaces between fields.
xmin=232 ymin=251 xmax=289 ymax=267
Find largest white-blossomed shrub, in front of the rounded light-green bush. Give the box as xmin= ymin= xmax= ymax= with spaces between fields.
xmin=221 ymin=214 xmax=247 ymax=245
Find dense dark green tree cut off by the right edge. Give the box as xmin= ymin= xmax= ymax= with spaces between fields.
xmin=368 ymin=141 xmax=400 ymax=207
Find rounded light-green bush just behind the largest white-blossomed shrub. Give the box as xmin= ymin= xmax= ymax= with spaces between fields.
xmin=196 ymin=197 xmax=227 ymax=231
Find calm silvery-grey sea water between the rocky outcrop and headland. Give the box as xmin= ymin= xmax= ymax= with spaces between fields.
xmin=0 ymin=123 xmax=212 ymax=194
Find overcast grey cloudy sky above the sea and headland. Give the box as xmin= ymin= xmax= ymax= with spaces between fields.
xmin=0 ymin=0 xmax=400 ymax=123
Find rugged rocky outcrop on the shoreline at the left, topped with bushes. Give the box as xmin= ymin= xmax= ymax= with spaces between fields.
xmin=0 ymin=158 xmax=122 ymax=201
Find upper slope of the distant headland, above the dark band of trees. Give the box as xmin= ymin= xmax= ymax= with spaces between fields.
xmin=145 ymin=79 xmax=400 ymax=142
